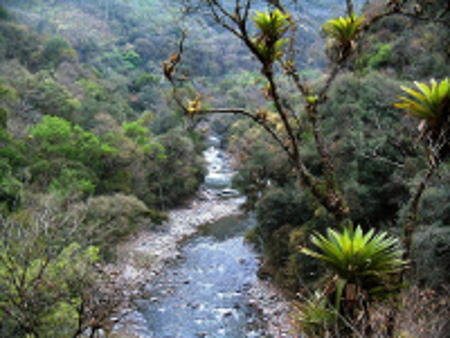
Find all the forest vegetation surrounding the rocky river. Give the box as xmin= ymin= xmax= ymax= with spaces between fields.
xmin=0 ymin=0 xmax=450 ymax=337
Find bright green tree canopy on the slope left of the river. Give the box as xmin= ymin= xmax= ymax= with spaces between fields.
xmin=29 ymin=116 xmax=118 ymax=197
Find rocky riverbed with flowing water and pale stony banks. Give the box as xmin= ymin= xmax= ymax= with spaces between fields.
xmin=114 ymin=138 xmax=289 ymax=337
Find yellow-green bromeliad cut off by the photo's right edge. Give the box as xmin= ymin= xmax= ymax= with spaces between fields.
xmin=394 ymin=78 xmax=450 ymax=160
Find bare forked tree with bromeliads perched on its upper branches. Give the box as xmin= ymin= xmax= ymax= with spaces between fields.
xmin=170 ymin=1 xmax=445 ymax=264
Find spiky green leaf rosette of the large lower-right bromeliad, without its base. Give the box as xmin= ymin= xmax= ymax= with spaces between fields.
xmin=301 ymin=226 xmax=406 ymax=290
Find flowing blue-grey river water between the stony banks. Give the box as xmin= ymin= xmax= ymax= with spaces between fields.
xmin=134 ymin=138 xmax=264 ymax=337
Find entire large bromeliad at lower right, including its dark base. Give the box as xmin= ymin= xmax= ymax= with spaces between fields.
xmin=297 ymin=225 xmax=406 ymax=327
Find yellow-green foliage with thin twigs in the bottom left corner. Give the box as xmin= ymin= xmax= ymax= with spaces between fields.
xmin=0 ymin=212 xmax=99 ymax=337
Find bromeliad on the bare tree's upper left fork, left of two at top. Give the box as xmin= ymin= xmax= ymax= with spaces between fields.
xmin=252 ymin=9 xmax=290 ymax=64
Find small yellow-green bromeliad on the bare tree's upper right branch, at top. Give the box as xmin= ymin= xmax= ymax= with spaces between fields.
xmin=322 ymin=14 xmax=365 ymax=49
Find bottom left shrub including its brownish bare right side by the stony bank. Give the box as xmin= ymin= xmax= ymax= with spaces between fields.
xmin=0 ymin=203 xmax=144 ymax=337
